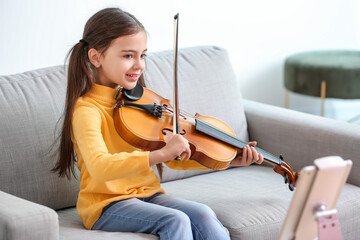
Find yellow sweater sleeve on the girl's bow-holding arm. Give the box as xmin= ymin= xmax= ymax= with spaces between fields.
xmin=72 ymin=106 xmax=150 ymax=182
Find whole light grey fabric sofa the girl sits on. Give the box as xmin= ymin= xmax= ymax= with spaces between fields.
xmin=0 ymin=46 xmax=360 ymax=240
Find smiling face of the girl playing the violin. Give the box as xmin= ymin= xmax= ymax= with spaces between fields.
xmin=93 ymin=31 xmax=147 ymax=90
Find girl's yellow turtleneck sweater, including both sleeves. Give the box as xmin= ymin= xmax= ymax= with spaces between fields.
xmin=71 ymin=84 xmax=207 ymax=229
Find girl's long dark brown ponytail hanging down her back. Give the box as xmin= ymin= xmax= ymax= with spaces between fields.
xmin=52 ymin=40 xmax=93 ymax=179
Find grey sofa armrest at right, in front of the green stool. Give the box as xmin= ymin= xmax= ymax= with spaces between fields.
xmin=244 ymin=100 xmax=360 ymax=186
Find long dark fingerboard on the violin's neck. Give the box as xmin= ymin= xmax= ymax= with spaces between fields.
xmin=195 ymin=119 xmax=281 ymax=165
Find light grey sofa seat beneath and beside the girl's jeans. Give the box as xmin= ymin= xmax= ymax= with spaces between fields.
xmin=57 ymin=165 xmax=360 ymax=240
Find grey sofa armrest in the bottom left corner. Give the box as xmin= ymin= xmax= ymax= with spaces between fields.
xmin=0 ymin=191 xmax=59 ymax=240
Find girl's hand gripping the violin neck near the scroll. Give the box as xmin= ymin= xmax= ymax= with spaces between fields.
xmin=230 ymin=142 xmax=264 ymax=166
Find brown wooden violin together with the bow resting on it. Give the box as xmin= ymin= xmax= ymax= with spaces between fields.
xmin=114 ymin=14 xmax=300 ymax=191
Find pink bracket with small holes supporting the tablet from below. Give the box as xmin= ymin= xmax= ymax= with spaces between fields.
xmin=315 ymin=205 xmax=342 ymax=240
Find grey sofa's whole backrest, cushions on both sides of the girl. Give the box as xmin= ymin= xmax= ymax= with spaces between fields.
xmin=0 ymin=47 xmax=247 ymax=209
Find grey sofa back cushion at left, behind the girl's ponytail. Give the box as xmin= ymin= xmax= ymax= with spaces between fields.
xmin=0 ymin=66 xmax=79 ymax=209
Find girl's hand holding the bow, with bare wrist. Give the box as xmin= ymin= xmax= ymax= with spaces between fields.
xmin=149 ymin=134 xmax=191 ymax=166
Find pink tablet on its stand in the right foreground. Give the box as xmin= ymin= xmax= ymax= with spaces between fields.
xmin=279 ymin=156 xmax=352 ymax=240
